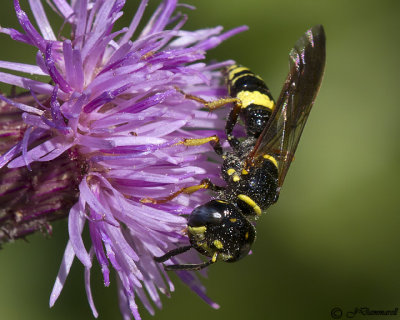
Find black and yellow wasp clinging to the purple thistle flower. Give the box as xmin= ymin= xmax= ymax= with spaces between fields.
xmin=144 ymin=25 xmax=325 ymax=270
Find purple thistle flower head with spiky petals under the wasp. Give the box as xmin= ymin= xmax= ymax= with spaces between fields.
xmin=0 ymin=0 xmax=246 ymax=319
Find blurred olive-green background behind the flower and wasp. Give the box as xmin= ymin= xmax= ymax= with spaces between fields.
xmin=0 ymin=0 xmax=400 ymax=320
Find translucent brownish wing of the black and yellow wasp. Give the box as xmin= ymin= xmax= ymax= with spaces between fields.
xmin=247 ymin=25 xmax=325 ymax=194
